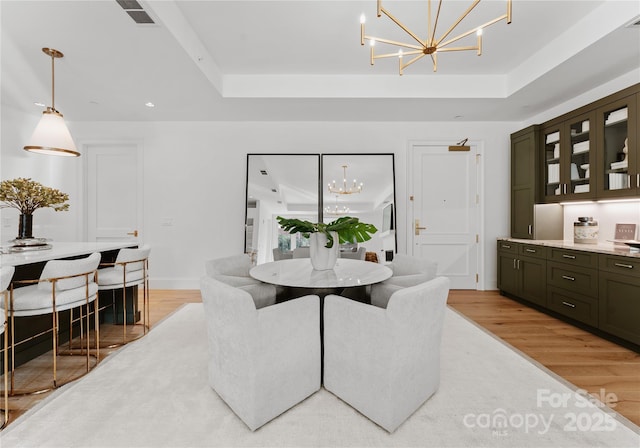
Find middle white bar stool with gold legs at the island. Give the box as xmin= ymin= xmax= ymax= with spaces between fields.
xmin=8 ymin=252 xmax=101 ymax=396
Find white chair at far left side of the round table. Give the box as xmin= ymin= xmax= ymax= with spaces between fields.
xmin=205 ymin=254 xmax=277 ymax=308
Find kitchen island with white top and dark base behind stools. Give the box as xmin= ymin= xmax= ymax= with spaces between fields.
xmin=0 ymin=242 xmax=138 ymax=366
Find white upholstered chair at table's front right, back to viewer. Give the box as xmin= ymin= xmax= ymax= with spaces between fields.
xmin=324 ymin=277 xmax=449 ymax=432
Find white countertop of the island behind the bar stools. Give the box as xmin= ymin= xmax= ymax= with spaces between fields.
xmin=0 ymin=241 xmax=137 ymax=266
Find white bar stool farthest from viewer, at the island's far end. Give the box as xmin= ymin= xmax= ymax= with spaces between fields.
xmin=98 ymin=245 xmax=151 ymax=348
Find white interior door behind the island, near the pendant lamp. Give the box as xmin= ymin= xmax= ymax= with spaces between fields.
xmin=84 ymin=143 xmax=143 ymax=241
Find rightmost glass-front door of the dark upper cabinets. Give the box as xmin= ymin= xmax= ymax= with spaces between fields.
xmin=597 ymin=95 xmax=640 ymax=197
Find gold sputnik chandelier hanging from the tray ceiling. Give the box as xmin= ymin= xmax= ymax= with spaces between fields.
xmin=360 ymin=0 xmax=511 ymax=75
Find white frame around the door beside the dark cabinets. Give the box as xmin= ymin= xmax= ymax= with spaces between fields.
xmin=405 ymin=138 xmax=486 ymax=291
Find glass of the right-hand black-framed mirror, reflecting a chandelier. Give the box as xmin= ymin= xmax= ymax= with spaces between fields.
xmin=322 ymin=154 xmax=396 ymax=263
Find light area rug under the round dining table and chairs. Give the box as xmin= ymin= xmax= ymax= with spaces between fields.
xmin=0 ymin=304 xmax=640 ymax=448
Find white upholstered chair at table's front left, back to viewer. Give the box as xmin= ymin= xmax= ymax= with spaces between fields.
xmin=201 ymin=277 xmax=320 ymax=431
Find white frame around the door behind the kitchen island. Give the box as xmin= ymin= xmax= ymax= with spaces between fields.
xmin=80 ymin=139 xmax=144 ymax=243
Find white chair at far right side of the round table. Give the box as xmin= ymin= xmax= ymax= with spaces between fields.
xmin=371 ymin=254 xmax=438 ymax=308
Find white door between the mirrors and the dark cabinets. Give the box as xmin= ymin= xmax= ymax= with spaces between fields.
xmin=408 ymin=143 xmax=479 ymax=289
